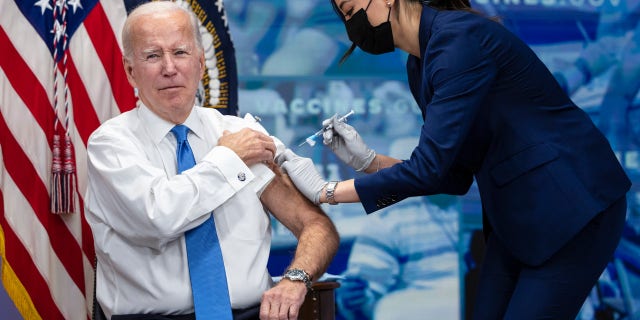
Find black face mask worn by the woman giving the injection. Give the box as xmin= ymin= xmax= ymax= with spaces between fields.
xmin=345 ymin=1 xmax=395 ymax=54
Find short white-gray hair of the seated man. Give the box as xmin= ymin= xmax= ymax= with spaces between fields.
xmin=122 ymin=1 xmax=204 ymax=59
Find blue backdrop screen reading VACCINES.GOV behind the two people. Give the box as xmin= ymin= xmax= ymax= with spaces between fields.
xmin=225 ymin=0 xmax=640 ymax=319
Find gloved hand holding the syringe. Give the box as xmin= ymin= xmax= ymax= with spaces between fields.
xmin=322 ymin=115 xmax=376 ymax=171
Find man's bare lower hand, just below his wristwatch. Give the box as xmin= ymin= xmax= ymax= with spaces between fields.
xmin=260 ymin=279 xmax=307 ymax=320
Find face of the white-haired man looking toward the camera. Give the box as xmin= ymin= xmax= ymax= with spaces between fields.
xmin=124 ymin=11 xmax=204 ymax=123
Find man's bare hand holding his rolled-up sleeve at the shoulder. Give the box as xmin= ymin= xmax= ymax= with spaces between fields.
xmin=218 ymin=128 xmax=276 ymax=166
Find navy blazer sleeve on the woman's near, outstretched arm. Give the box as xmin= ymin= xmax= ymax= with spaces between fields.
xmin=355 ymin=27 xmax=497 ymax=213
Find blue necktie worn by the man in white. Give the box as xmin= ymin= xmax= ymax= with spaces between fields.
xmin=171 ymin=125 xmax=232 ymax=320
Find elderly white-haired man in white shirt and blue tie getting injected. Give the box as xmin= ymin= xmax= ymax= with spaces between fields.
xmin=86 ymin=2 xmax=339 ymax=320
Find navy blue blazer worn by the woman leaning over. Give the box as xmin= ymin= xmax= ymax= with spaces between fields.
xmin=355 ymin=6 xmax=631 ymax=265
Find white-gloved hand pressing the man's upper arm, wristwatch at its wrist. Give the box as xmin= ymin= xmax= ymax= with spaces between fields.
xmin=275 ymin=149 xmax=327 ymax=204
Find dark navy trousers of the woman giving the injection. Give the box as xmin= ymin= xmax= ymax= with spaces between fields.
xmin=473 ymin=197 xmax=627 ymax=320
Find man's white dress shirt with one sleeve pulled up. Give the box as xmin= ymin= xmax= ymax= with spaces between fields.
xmin=85 ymin=104 xmax=284 ymax=318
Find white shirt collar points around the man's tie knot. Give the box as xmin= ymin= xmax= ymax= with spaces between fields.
xmin=138 ymin=102 xmax=204 ymax=144
